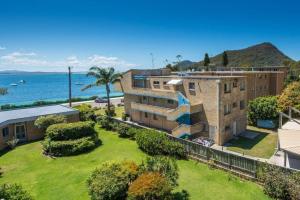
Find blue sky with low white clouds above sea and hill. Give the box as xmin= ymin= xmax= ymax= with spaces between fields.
xmin=0 ymin=0 xmax=300 ymax=71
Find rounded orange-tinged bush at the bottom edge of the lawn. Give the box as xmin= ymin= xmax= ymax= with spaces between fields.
xmin=128 ymin=172 xmax=172 ymax=200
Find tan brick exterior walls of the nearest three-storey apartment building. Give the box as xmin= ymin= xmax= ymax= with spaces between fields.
xmin=121 ymin=71 xmax=248 ymax=145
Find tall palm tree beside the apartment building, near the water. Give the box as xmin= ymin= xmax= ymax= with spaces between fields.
xmin=81 ymin=66 xmax=121 ymax=116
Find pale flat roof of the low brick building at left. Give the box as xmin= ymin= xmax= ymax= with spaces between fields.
xmin=0 ymin=105 xmax=79 ymax=126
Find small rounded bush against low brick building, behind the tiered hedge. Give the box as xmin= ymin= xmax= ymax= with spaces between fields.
xmin=34 ymin=115 xmax=67 ymax=131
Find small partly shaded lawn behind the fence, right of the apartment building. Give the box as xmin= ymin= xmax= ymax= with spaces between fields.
xmin=227 ymin=126 xmax=278 ymax=158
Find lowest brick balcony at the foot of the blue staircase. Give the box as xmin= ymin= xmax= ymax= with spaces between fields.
xmin=172 ymin=122 xmax=204 ymax=137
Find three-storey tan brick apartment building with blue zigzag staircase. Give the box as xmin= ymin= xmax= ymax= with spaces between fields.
xmin=116 ymin=69 xmax=247 ymax=145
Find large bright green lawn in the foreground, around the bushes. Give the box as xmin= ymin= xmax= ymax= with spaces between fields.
xmin=0 ymin=126 xmax=268 ymax=200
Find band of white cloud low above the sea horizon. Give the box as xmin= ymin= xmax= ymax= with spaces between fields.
xmin=0 ymin=51 xmax=136 ymax=71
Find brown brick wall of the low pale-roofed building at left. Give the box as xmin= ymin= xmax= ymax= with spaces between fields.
xmin=0 ymin=114 xmax=79 ymax=150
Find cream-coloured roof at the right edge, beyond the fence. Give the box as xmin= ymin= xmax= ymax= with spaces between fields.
xmin=278 ymin=129 xmax=300 ymax=155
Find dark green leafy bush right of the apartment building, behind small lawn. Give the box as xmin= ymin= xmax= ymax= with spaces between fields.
xmin=247 ymin=96 xmax=278 ymax=125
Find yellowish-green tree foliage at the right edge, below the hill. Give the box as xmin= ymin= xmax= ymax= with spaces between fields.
xmin=278 ymin=81 xmax=300 ymax=111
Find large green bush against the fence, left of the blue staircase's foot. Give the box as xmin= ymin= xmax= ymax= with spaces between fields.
xmin=135 ymin=129 xmax=187 ymax=158
